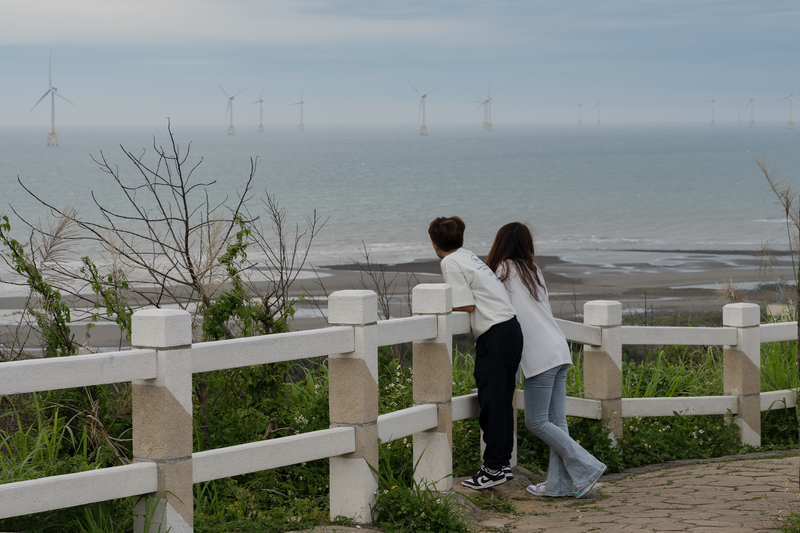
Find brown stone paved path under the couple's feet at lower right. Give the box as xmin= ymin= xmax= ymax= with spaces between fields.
xmin=308 ymin=454 xmax=800 ymax=533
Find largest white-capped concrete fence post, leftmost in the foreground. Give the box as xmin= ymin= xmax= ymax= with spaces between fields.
xmin=131 ymin=309 xmax=194 ymax=533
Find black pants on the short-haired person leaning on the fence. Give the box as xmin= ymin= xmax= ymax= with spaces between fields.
xmin=473 ymin=317 xmax=522 ymax=470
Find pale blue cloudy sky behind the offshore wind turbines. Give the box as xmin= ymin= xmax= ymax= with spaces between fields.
xmin=0 ymin=0 xmax=800 ymax=128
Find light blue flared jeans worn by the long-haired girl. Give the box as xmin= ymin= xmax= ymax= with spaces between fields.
xmin=525 ymin=365 xmax=603 ymax=496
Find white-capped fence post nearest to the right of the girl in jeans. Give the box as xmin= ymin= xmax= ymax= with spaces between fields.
xmin=583 ymin=300 xmax=622 ymax=442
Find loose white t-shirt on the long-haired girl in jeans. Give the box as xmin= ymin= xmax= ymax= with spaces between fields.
xmin=496 ymin=261 xmax=572 ymax=378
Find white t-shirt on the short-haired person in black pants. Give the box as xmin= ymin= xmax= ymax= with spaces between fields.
xmin=441 ymin=248 xmax=516 ymax=337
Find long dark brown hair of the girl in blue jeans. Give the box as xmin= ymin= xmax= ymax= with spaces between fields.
xmin=486 ymin=222 xmax=544 ymax=301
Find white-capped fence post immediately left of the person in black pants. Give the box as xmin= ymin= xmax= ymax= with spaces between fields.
xmin=411 ymin=283 xmax=453 ymax=491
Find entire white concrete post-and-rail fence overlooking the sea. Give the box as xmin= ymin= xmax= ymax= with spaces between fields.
xmin=0 ymin=284 xmax=797 ymax=533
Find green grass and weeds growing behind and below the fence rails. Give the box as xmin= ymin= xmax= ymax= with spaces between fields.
xmin=0 ymin=320 xmax=800 ymax=533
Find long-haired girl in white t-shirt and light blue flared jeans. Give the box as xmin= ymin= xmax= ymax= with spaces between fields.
xmin=486 ymin=222 xmax=606 ymax=498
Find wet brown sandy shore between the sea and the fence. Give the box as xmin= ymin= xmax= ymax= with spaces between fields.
xmin=0 ymin=250 xmax=793 ymax=347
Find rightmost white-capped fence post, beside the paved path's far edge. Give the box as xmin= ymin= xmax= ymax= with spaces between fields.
xmin=722 ymin=303 xmax=761 ymax=446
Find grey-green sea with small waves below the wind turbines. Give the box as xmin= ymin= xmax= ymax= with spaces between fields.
xmin=0 ymin=122 xmax=800 ymax=295
